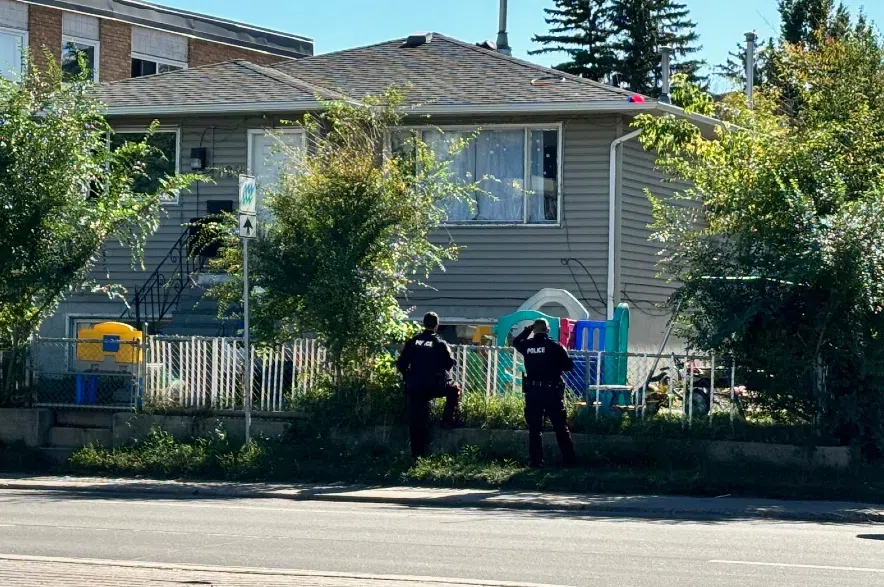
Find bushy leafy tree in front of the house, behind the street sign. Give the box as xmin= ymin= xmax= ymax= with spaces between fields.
xmin=209 ymin=91 xmax=477 ymax=373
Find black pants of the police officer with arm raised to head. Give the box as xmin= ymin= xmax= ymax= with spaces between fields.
xmin=525 ymin=382 xmax=577 ymax=466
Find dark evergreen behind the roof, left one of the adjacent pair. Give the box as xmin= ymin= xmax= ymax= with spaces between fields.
xmin=528 ymin=0 xmax=616 ymax=81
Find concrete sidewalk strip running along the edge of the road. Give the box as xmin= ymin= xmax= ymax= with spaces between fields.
xmin=0 ymin=475 xmax=884 ymax=523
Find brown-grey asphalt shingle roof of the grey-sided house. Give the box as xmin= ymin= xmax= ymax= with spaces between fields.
xmin=96 ymin=33 xmax=644 ymax=115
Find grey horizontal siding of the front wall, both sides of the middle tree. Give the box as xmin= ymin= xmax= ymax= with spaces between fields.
xmin=46 ymin=115 xmax=618 ymax=335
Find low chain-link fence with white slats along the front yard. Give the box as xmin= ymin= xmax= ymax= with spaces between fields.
xmin=20 ymin=336 xmax=746 ymax=422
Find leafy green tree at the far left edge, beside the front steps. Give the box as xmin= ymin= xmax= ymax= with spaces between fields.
xmin=0 ymin=58 xmax=193 ymax=386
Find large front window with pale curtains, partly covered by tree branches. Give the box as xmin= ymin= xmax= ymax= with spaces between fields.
xmin=391 ymin=125 xmax=560 ymax=224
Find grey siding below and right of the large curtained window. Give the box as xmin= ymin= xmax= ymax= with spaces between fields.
xmin=408 ymin=116 xmax=616 ymax=319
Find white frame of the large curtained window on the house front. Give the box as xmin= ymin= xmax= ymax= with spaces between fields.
xmin=385 ymin=122 xmax=564 ymax=229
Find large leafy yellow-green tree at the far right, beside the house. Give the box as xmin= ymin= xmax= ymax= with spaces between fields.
xmin=636 ymin=30 xmax=884 ymax=455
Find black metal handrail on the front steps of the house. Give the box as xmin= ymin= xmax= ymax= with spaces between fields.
xmin=120 ymin=228 xmax=206 ymax=332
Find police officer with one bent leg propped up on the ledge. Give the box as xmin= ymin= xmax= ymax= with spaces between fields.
xmin=396 ymin=312 xmax=460 ymax=457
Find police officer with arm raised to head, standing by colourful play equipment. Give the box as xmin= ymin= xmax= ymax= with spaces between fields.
xmin=513 ymin=319 xmax=577 ymax=467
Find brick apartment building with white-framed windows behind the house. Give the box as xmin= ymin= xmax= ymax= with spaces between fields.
xmin=0 ymin=0 xmax=313 ymax=82
